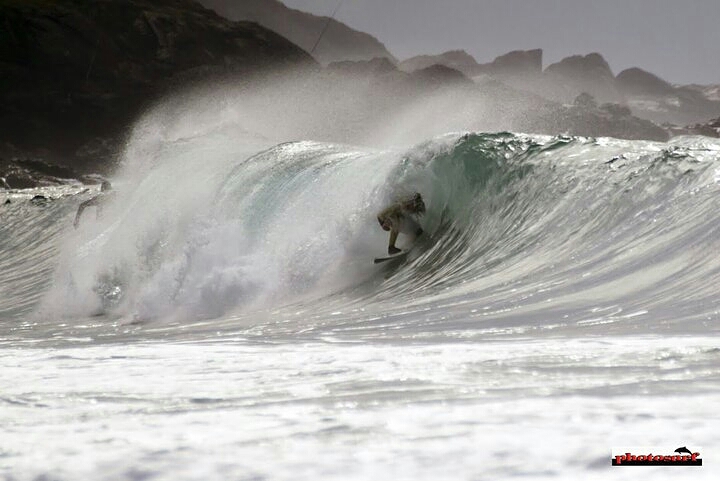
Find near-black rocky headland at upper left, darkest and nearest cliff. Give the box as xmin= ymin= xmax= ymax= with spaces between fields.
xmin=0 ymin=0 xmax=313 ymax=170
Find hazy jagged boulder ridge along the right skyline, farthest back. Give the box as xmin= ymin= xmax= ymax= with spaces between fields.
xmin=400 ymin=49 xmax=720 ymax=128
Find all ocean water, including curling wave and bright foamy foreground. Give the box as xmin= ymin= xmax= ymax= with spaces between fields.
xmin=0 ymin=94 xmax=720 ymax=481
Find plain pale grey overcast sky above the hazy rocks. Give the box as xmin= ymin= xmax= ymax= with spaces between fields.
xmin=282 ymin=0 xmax=720 ymax=84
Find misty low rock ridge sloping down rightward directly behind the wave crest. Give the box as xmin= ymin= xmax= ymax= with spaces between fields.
xmin=322 ymin=59 xmax=668 ymax=141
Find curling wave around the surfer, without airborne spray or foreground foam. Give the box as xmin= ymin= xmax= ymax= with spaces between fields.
xmin=0 ymin=131 xmax=720 ymax=338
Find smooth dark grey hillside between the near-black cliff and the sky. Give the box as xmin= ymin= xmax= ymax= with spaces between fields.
xmin=199 ymin=0 xmax=396 ymax=64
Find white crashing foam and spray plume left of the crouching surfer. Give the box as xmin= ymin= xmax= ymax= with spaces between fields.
xmin=14 ymin=68 xmax=510 ymax=321
